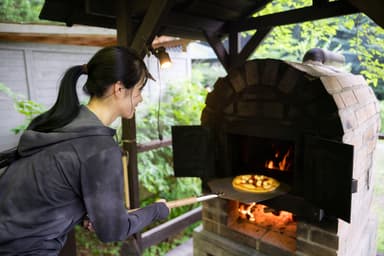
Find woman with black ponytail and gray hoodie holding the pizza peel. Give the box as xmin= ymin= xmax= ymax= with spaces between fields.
xmin=0 ymin=47 xmax=169 ymax=255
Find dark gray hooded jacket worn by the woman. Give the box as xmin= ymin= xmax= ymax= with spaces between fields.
xmin=0 ymin=106 xmax=169 ymax=255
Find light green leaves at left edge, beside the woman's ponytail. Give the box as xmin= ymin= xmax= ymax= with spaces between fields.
xmin=0 ymin=83 xmax=46 ymax=134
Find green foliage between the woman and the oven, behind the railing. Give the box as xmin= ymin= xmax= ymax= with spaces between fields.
xmin=136 ymin=79 xmax=207 ymax=256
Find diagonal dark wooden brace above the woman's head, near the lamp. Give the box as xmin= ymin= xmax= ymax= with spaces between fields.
xmin=131 ymin=0 xmax=173 ymax=57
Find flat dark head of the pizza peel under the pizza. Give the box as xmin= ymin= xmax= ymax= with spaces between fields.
xmin=208 ymin=177 xmax=290 ymax=204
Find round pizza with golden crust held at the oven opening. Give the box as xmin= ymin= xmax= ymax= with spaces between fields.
xmin=232 ymin=174 xmax=280 ymax=193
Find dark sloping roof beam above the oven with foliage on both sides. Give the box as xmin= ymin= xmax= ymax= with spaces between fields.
xmin=231 ymin=1 xmax=359 ymax=32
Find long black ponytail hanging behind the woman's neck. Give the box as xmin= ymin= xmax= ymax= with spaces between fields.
xmin=27 ymin=65 xmax=87 ymax=132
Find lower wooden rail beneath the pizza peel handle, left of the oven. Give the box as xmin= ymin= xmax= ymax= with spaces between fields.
xmin=142 ymin=206 xmax=202 ymax=248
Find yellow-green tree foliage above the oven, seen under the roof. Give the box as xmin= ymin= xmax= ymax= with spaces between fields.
xmin=247 ymin=0 xmax=384 ymax=98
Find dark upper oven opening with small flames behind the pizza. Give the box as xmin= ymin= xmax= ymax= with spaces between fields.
xmin=228 ymin=134 xmax=295 ymax=183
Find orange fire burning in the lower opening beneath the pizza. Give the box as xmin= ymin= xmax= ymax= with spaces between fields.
xmin=238 ymin=203 xmax=294 ymax=228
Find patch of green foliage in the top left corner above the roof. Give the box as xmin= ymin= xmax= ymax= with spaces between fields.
xmin=0 ymin=0 xmax=44 ymax=23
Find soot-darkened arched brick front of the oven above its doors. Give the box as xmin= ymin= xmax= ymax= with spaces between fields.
xmin=201 ymin=59 xmax=344 ymax=140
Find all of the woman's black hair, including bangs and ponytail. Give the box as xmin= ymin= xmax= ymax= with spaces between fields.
xmin=27 ymin=46 xmax=152 ymax=132
